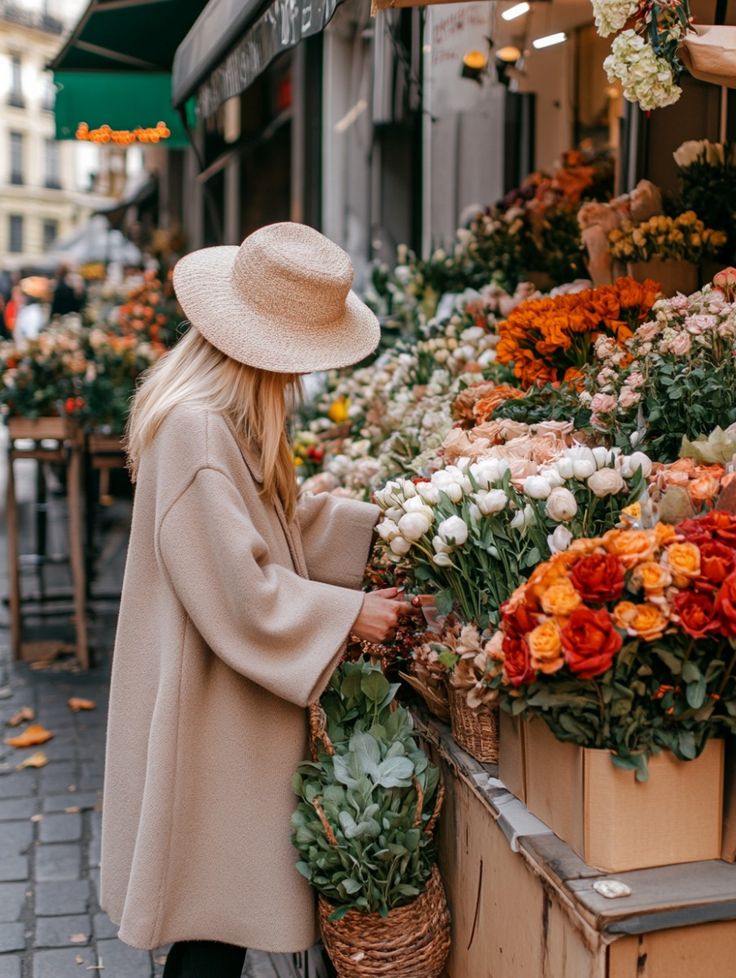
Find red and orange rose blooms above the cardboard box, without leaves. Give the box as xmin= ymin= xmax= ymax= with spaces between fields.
xmin=498 ymin=511 xmax=736 ymax=688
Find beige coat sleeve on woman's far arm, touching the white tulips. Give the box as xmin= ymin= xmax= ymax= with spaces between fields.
xmin=297 ymin=492 xmax=380 ymax=588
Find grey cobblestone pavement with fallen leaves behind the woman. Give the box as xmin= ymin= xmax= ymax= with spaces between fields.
xmin=0 ymin=446 xmax=323 ymax=978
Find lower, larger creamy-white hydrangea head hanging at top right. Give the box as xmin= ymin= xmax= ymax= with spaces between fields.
xmin=603 ymin=30 xmax=682 ymax=112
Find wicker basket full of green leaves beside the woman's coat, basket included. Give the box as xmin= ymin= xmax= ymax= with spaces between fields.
xmin=292 ymin=660 xmax=450 ymax=978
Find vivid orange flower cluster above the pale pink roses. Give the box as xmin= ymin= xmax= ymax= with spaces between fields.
xmin=496 ymin=278 xmax=660 ymax=387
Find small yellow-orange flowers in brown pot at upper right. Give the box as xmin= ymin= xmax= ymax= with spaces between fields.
xmin=608 ymin=211 xmax=727 ymax=296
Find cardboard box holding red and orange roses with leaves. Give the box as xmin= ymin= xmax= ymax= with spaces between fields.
xmin=484 ymin=510 xmax=736 ymax=871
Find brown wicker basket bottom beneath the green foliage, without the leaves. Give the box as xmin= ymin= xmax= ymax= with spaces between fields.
xmin=319 ymin=866 xmax=450 ymax=978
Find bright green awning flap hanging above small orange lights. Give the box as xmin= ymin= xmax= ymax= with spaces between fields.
xmin=54 ymin=71 xmax=193 ymax=149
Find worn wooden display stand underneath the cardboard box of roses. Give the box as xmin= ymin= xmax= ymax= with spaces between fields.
xmin=417 ymin=716 xmax=736 ymax=978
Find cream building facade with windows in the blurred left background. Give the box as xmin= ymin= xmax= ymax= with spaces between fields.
xmin=0 ymin=0 xmax=100 ymax=270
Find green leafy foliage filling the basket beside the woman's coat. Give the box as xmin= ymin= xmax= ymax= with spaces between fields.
xmin=292 ymin=660 xmax=439 ymax=919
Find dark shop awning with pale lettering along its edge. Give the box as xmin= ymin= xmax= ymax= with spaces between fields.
xmin=172 ymin=0 xmax=342 ymax=118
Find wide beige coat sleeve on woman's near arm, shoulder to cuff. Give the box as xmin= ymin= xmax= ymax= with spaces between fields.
xmin=158 ymin=468 xmax=364 ymax=706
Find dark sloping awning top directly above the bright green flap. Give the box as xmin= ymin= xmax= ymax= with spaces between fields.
xmin=50 ymin=0 xmax=210 ymax=71
